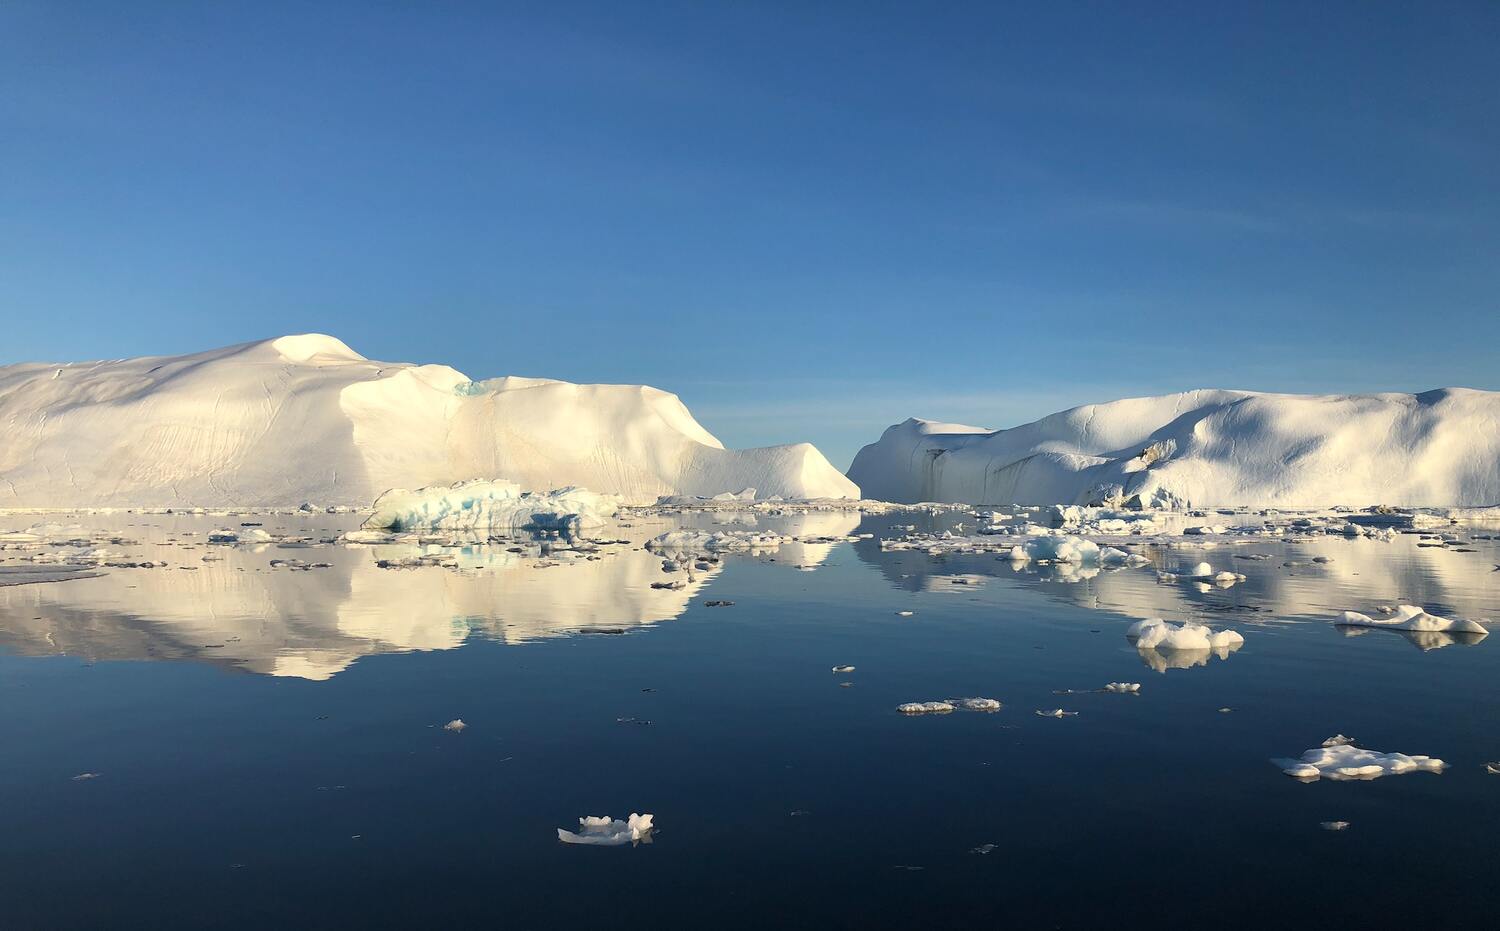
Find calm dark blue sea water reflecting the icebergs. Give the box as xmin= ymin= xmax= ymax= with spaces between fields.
xmin=0 ymin=514 xmax=1500 ymax=928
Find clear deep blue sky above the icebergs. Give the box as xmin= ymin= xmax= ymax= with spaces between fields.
xmin=0 ymin=0 xmax=1500 ymax=466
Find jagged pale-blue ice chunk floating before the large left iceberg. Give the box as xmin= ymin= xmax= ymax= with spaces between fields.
xmin=360 ymin=478 xmax=620 ymax=532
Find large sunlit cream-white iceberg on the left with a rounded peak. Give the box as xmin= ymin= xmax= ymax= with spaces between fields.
xmin=0 ymin=334 xmax=860 ymax=507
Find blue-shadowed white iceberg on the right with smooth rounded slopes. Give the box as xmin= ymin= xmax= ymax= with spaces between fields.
xmin=849 ymin=388 xmax=1500 ymax=507
